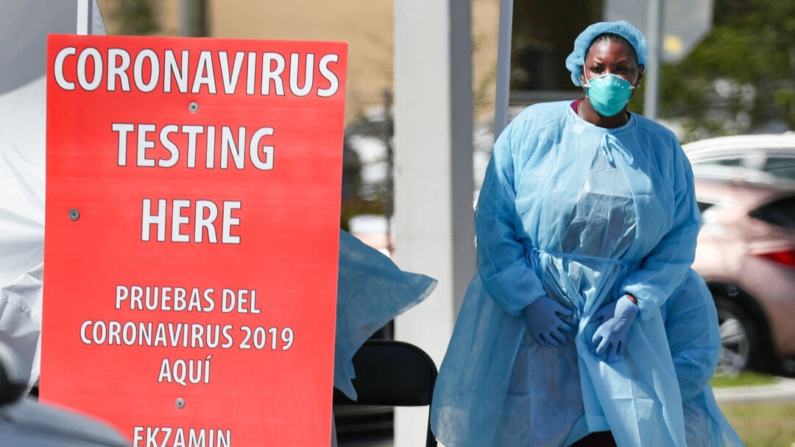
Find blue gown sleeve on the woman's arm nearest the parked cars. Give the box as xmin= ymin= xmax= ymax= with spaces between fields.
xmin=621 ymin=141 xmax=701 ymax=320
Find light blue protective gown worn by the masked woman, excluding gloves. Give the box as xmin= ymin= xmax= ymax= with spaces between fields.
xmin=431 ymin=102 xmax=700 ymax=447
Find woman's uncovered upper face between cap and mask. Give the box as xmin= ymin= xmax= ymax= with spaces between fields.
xmin=581 ymin=39 xmax=644 ymax=87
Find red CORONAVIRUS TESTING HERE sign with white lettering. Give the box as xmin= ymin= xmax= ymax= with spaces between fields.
xmin=40 ymin=35 xmax=347 ymax=447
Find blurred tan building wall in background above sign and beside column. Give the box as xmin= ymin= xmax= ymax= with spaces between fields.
xmin=98 ymin=0 xmax=500 ymax=121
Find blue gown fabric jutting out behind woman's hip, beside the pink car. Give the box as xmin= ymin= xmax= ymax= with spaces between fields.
xmin=660 ymin=270 xmax=744 ymax=447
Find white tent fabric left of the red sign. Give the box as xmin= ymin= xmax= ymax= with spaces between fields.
xmin=0 ymin=0 xmax=105 ymax=381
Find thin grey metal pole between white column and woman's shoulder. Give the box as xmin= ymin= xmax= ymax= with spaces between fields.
xmin=494 ymin=0 xmax=513 ymax=141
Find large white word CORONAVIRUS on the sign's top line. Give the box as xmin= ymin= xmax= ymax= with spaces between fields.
xmin=53 ymin=47 xmax=340 ymax=98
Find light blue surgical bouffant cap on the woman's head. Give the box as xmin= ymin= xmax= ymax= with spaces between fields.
xmin=566 ymin=20 xmax=649 ymax=87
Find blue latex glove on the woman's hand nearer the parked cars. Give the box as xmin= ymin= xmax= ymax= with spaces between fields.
xmin=591 ymin=295 xmax=640 ymax=362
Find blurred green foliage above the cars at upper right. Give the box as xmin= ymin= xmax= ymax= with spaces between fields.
xmin=664 ymin=0 xmax=795 ymax=139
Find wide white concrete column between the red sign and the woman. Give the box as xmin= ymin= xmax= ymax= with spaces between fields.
xmin=394 ymin=0 xmax=476 ymax=447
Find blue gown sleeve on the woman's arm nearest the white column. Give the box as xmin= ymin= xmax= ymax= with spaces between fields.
xmin=475 ymin=118 xmax=546 ymax=315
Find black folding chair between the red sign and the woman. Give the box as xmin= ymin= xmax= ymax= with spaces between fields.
xmin=334 ymin=340 xmax=437 ymax=447
